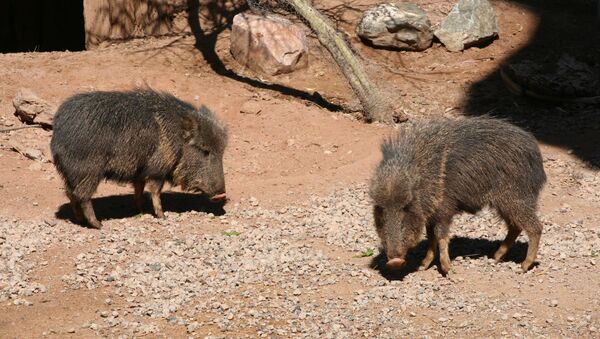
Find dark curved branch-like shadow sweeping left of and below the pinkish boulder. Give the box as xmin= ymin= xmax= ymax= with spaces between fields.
xmin=187 ymin=0 xmax=342 ymax=111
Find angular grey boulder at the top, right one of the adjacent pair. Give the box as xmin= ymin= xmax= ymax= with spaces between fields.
xmin=434 ymin=0 xmax=498 ymax=52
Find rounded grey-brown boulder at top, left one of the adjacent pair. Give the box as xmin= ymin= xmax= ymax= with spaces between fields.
xmin=356 ymin=3 xmax=433 ymax=51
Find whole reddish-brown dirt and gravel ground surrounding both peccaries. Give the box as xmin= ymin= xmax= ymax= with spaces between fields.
xmin=0 ymin=0 xmax=600 ymax=338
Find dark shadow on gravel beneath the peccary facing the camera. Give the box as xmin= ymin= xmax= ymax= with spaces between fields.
xmin=369 ymin=237 xmax=527 ymax=280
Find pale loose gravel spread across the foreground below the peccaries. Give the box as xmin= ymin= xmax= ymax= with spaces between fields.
xmin=0 ymin=158 xmax=600 ymax=338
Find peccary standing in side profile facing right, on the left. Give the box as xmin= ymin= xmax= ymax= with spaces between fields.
xmin=50 ymin=90 xmax=227 ymax=228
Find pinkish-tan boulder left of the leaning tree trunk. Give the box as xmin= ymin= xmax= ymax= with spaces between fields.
xmin=230 ymin=13 xmax=308 ymax=75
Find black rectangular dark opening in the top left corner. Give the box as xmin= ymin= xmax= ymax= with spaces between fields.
xmin=0 ymin=0 xmax=85 ymax=53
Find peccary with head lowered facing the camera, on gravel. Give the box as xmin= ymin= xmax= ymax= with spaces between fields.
xmin=370 ymin=117 xmax=546 ymax=275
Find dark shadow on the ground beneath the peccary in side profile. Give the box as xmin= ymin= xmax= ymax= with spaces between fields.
xmin=56 ymin=192 xmax=225 ymax=227
